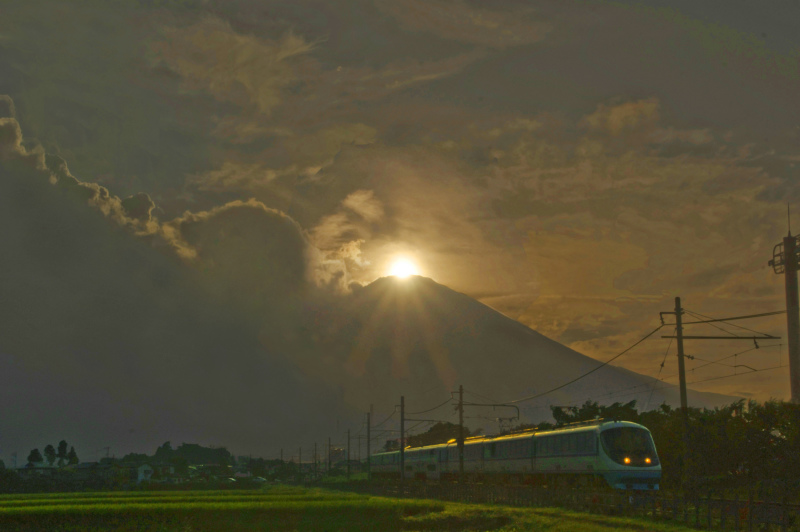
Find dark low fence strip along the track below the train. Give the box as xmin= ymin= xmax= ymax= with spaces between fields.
xmin=326 ymin=482 xmax=800 ymax=532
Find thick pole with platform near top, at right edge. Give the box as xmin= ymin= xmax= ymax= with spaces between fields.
xmin=769 ymin=221 xmax=800 ymax=404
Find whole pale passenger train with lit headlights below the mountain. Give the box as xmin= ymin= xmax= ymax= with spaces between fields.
xmin=370 ymin=420 xmax=661 ymax=490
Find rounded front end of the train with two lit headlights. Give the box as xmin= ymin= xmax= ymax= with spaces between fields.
xmin=598 ymin=421 xmax=661 ymax=490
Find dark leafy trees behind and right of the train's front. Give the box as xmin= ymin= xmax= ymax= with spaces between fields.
xmin=539 ymin=400 xmax=800 ymax=488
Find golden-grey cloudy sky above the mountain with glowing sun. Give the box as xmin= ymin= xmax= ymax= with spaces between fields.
xmin=0 ymin=0 xmax=800 ymax=458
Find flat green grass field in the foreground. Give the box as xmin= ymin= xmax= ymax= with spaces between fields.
xmin=0 ymin=487 xmax=689 ymax=532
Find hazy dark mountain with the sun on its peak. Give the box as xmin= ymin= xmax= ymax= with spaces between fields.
xmin=310 ymin=276 xmax=734 ymax=429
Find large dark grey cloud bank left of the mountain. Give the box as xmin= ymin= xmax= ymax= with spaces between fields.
xmin=0 ymin=107 xmax=358 ymax=454
